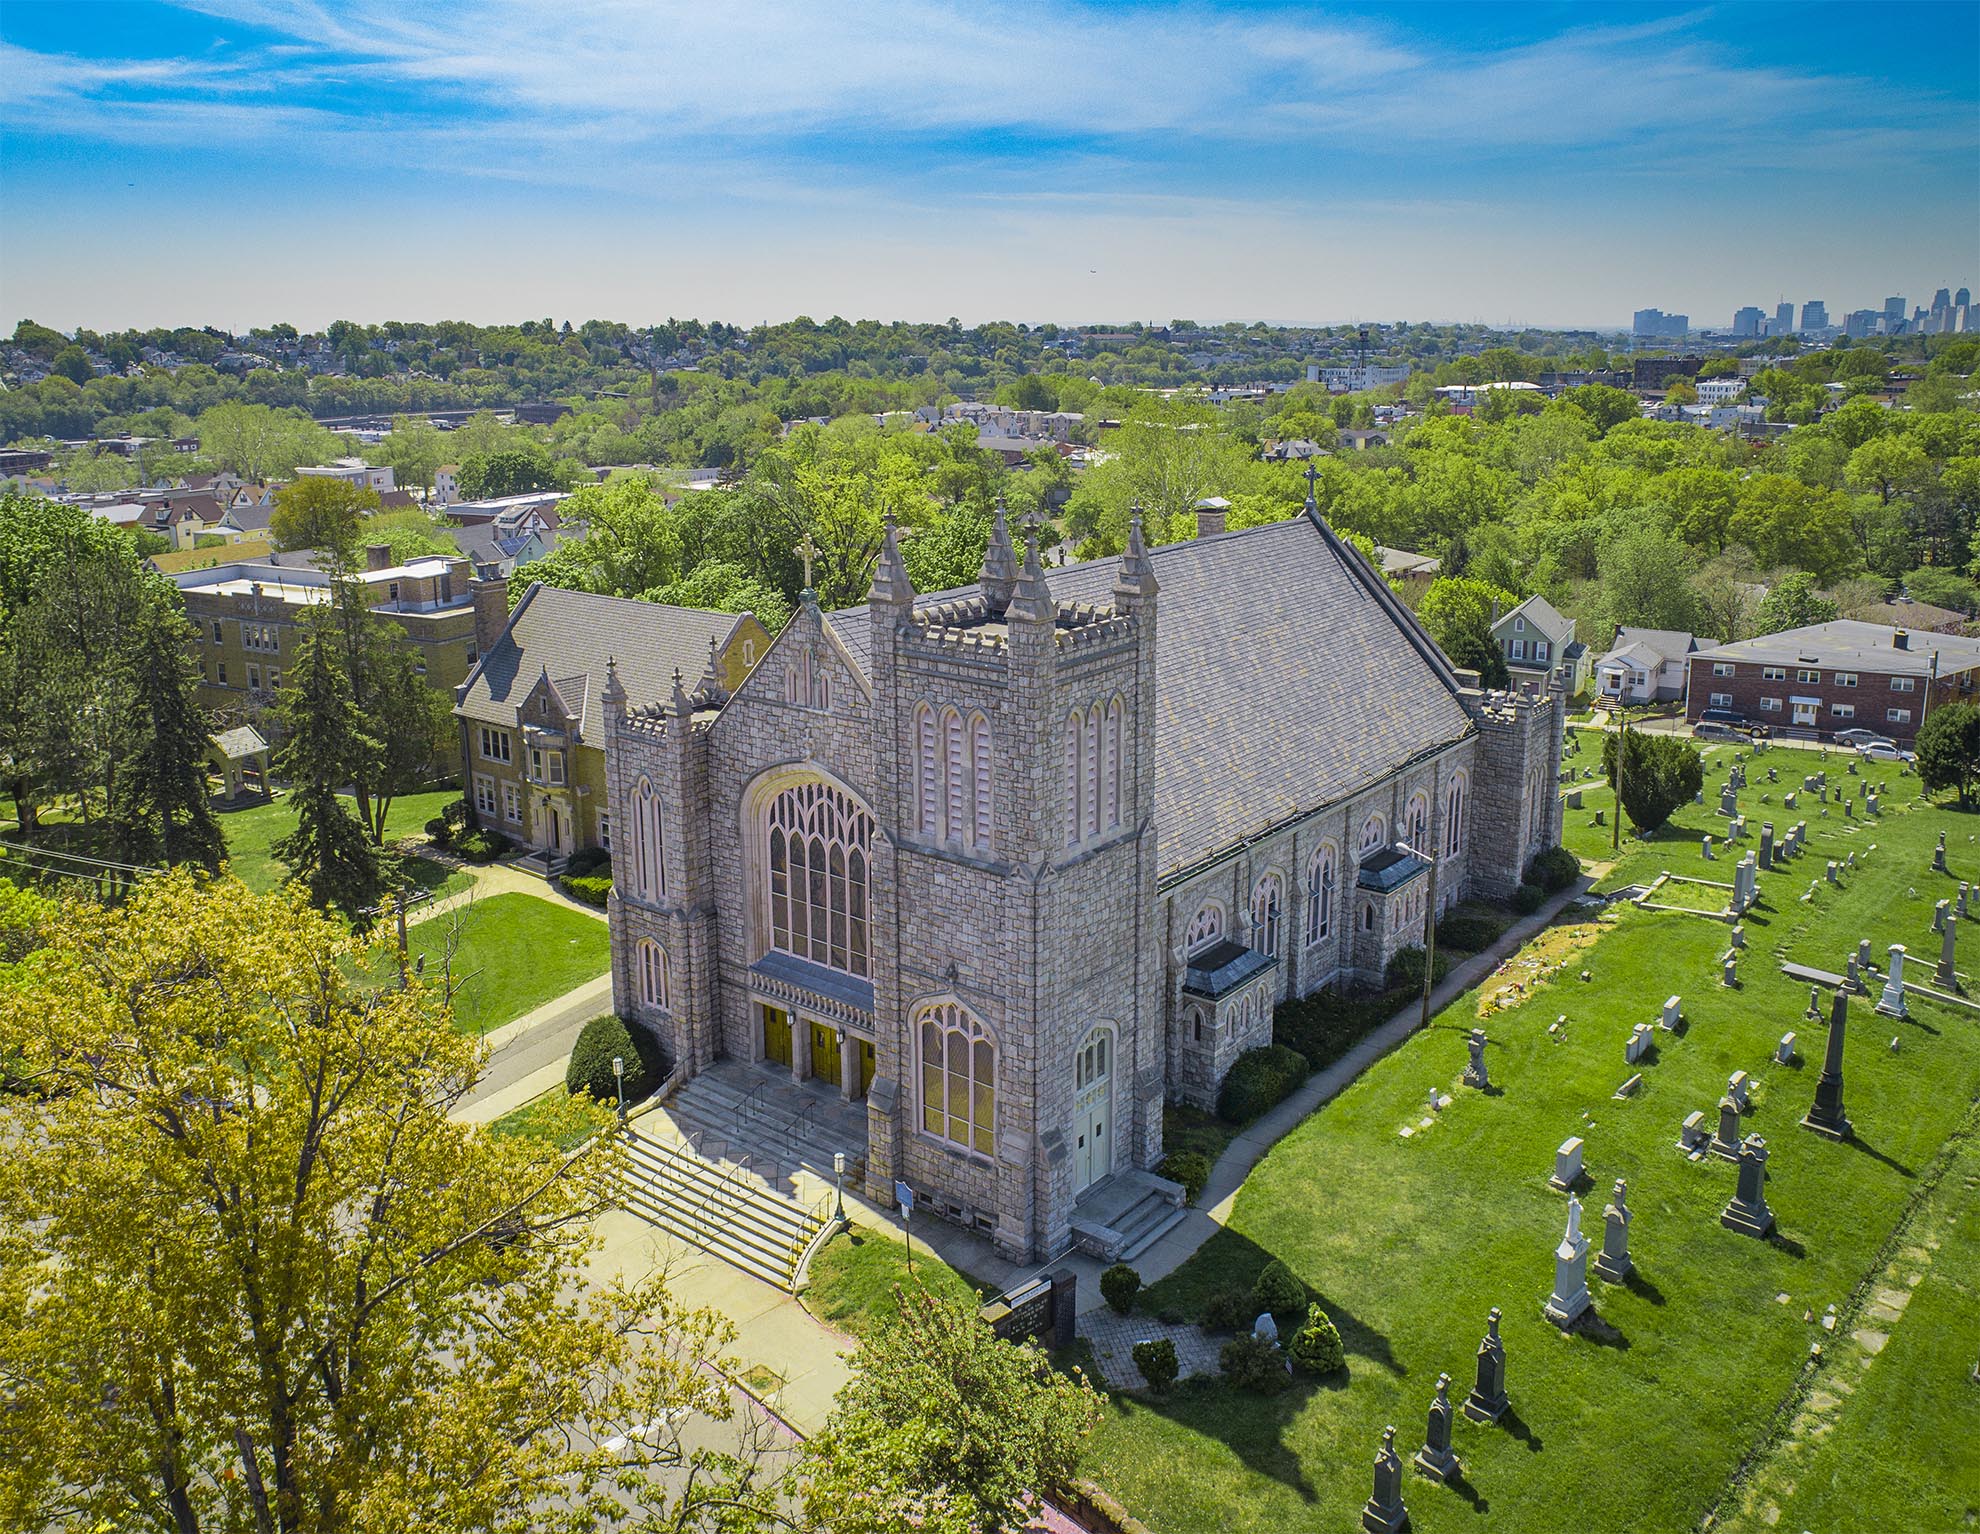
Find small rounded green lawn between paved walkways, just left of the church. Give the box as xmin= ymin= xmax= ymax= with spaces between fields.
xmin=399 ymin=895 xmax=612 ymax=1033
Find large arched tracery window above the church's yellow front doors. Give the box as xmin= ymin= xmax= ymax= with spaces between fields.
xmin=764 ymin=782 xmax=873 ymax=976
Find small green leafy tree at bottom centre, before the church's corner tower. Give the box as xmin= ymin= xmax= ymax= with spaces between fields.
xmin=804 ymin=1287 xmax=1099 ymax=1534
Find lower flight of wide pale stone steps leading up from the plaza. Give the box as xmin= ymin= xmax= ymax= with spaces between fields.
xmin=620 ymin=1126 xmax=830 ymax=1293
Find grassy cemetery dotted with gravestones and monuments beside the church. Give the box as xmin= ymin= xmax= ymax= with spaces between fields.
xmin=1087 ymin=746 xmax=1980 ymax=1534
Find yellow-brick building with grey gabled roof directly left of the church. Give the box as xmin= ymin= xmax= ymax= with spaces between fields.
xmin=453 ymin=578 xmax=770 ymax=865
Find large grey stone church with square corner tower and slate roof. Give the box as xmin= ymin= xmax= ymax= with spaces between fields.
xmin=602 ymin=501 xmax=1564 ymax=1261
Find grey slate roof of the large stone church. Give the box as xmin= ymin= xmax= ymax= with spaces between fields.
xmin=832 ymin=515 xmax=1473 ymax=877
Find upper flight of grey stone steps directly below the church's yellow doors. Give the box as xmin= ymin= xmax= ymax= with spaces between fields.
xmin=665 ymin=1063 xmax=865 ymax=1194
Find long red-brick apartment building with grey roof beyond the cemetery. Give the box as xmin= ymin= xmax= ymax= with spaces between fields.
xmin=1685 ymin=618 xmax=1980 ymax=744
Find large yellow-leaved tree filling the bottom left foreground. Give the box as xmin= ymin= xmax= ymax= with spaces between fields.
xmin=0 ymin=875 xmax=770 ymax=1534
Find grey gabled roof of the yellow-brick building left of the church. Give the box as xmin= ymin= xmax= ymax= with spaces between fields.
xmin=455 ymin=582 xmax=743 ymax=744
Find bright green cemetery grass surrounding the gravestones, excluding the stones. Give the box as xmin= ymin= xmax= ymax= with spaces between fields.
xmin=1087 ymin=787 xmax=1980 ymax=1534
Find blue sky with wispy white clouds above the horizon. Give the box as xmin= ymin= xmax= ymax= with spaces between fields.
xmin=0 ymin=0 xmax=1980 ymax=329
